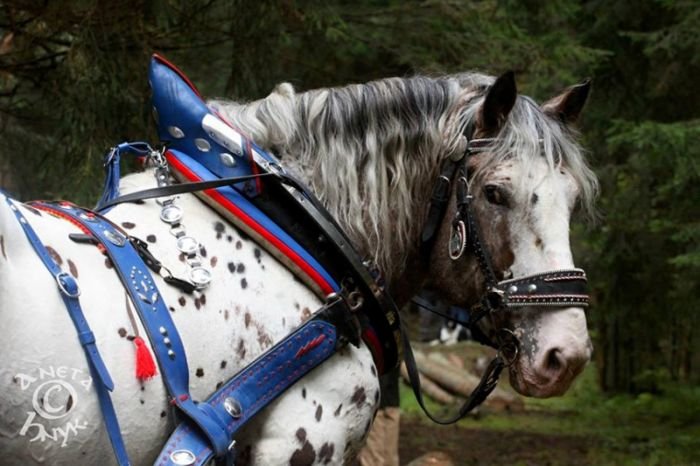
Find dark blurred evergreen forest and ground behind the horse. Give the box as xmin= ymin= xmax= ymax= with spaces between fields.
xmin=0 ymin=0 xmax=700 ymax=464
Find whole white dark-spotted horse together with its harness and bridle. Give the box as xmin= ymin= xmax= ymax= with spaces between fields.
xmin=0 ymin=56 xmax=596 ymax=465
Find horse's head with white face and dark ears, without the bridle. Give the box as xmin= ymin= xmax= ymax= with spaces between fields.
xmin=429 ymin=73 xmax=596 ymax=397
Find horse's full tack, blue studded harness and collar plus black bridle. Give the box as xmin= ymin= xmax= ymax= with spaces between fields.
xmin=7 ymin=56 xmax=588 ymax=466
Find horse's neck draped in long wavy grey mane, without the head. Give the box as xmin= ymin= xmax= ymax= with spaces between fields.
xmin=213 ymin=78 xmax=459 ymax=287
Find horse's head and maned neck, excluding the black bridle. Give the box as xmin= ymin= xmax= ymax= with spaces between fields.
xmin=211 ymin=69 xmax=596 ymax=396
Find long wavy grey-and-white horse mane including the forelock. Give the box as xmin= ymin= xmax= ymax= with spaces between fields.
xmin=209 ymin=73 xmax=596 ymax=274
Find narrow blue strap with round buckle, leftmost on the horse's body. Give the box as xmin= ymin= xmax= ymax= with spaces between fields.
xmin=5 ymin=196 xmax=130 ymax=466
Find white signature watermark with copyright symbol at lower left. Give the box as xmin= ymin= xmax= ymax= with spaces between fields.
xmin=15 ymin=366 xmax=92 ymax=447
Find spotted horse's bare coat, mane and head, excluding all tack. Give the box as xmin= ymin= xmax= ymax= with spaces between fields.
xmin=0 ymin=66 xmax=596 ymax=465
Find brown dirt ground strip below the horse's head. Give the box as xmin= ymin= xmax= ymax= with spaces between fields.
xmin=399 ymin=416 xmax=591 ymax=466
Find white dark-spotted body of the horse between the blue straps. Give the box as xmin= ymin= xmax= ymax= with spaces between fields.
xmin=0 ymin=187 xmax=379 ymax=464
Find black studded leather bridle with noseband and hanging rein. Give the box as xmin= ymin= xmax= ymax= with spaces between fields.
xmin=404 ymin=125 xmax=589 ymax=424
